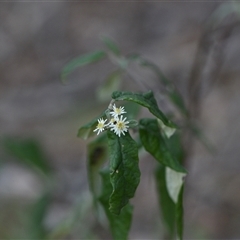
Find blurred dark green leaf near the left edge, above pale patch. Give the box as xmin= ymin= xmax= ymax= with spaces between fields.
xmin=3 ymin=137 xmax=51 ymax=174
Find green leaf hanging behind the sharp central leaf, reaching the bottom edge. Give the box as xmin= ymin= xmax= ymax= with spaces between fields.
xmin=99 ymin=169 xmax=133 ymax=240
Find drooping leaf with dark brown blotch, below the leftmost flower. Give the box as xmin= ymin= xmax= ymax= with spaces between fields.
xmin=87 ymin=133 xmax=108 ymax=208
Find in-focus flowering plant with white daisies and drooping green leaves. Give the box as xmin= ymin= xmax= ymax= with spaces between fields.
xmin=62 ymin=38 xmax=188 ymax=239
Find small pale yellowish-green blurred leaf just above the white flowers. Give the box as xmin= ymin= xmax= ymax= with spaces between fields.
xmin=97 ymin=70 xmax=122 ymax=101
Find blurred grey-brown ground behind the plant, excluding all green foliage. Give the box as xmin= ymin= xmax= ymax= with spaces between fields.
xmin=0 ymin=1 xmax=240 ymax=239
